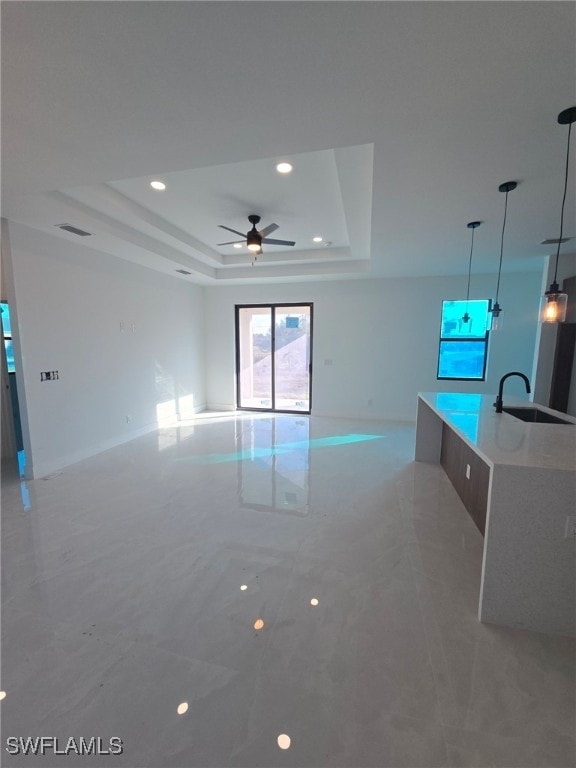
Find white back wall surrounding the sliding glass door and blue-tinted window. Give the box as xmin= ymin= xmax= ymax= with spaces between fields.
xmin=205 ymin=272 xmax=541 ymax=421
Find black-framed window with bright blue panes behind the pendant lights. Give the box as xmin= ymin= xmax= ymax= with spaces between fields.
xmin=437 ymin=299 xmax=490 ymax=381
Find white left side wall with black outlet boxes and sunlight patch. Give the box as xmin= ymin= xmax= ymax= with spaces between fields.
xmin=8 ymin=222 xmax=206 ymax=477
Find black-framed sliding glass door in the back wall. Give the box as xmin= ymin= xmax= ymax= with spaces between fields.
xmin=236 ymin=304 xmax=312 ymax=413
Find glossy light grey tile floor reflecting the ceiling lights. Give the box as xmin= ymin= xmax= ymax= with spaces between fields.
xmin=0 ymin=413 xmax=575 ymax=768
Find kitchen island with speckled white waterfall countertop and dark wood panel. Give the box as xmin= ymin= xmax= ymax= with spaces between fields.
xmin=415 ymin=392 xmax=576 ymax=636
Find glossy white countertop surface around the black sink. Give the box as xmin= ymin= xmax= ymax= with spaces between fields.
xmin=418 ymin=392 xmax=576 ymax=471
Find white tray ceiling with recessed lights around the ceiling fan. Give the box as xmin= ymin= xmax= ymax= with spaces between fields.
xmin=2 ymin=0 xmax=576 ymax=285
